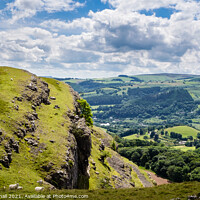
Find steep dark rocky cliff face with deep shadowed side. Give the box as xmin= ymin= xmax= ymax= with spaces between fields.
xmin=45 ymin=88 xmax=91 ymax=189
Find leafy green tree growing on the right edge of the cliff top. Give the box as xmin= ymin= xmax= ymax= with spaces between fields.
xmin=77 ymin=99 xmax=93 ymax=126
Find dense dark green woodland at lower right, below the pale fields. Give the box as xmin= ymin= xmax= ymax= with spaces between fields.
xmin=118 ymin=142 xmax=200 ymax=182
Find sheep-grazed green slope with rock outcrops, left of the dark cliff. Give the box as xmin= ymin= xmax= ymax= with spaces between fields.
xmin=0 ymin=67 xmax=74 ymax=188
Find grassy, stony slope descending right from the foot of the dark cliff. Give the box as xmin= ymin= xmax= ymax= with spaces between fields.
xmin=89 ymin=127 xmax=152 ymax=190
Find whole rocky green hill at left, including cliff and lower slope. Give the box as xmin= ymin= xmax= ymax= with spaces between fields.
xmin=0 ymin=67 xmax=151 ymax=191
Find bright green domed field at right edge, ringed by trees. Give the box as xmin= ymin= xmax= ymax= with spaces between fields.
xmin=165 ymin=126 xmax=199 ymax=138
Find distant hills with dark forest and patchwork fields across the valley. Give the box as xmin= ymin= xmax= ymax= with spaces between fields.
xmin=54 ymin=73 xmax=200 ymax=132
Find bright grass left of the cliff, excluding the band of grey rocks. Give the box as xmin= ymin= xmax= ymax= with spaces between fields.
xmin=0 ymin=67 xmax=74 ymax=189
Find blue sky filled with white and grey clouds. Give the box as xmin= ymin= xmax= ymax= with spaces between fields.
xmin=0 ymin=0 xmax=200 ymax=78
